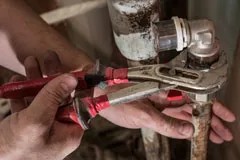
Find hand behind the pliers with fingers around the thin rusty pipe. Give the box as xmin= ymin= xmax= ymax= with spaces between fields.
xmin=96 ymin=85 xmax=236 ymax=144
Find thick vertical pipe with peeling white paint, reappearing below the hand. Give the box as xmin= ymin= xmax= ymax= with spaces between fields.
xmin=108 ymin=0 xmax=170 ymax=160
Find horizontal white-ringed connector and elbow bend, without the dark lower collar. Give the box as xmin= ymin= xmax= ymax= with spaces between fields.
xmin=153 ymin=17 xmax=215 ymax=52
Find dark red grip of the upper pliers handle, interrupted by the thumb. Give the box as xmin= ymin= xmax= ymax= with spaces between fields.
xmin=0 ymin=72 xmax=87 ymax=99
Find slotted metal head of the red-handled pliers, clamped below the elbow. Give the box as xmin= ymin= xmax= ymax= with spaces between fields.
xmin=128 ymin=47 xmax=228 ymax=97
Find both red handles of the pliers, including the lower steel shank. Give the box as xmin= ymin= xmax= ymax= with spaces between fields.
xmin=0 ymin=66 xmax=180 ymax=129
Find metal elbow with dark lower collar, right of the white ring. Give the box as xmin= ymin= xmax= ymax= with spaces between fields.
xmin=188 ymin=20 xmax=220 ymax=70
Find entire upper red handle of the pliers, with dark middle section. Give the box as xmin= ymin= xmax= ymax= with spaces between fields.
xmin=0 ymin=68 xmax=127 ymax=99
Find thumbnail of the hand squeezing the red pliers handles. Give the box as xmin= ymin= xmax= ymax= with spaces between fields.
xmin=61 ymin=74 xmax=78 ymax=92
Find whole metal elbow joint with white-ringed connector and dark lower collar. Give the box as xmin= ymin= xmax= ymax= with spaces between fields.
xmin=153 ymin=17 xmax=220 ymax=70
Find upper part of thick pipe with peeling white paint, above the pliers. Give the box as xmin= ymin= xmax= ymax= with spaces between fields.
xmin=108 ymin=0 xmax=160 ymax=61
